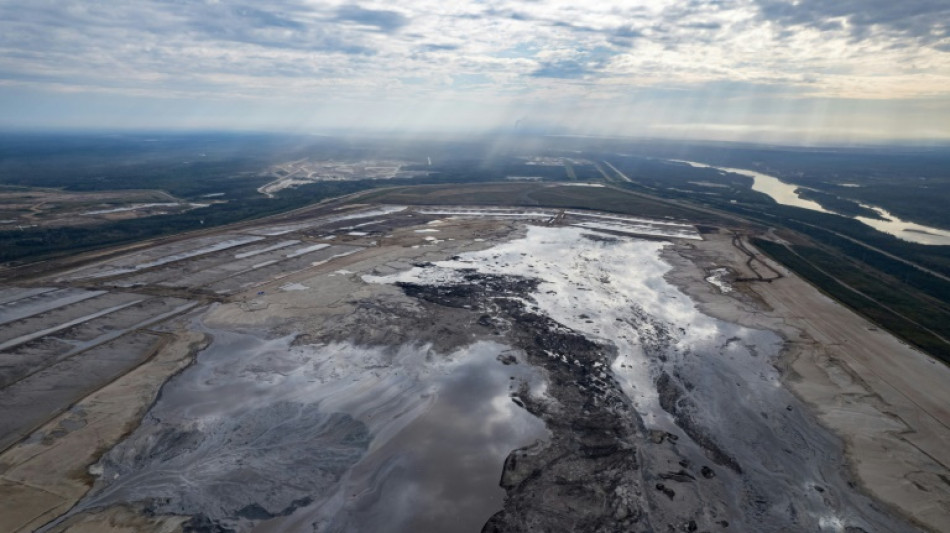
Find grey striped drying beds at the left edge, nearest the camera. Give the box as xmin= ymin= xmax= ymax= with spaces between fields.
xmin=0 ymin=289 xmax=201 ymax=450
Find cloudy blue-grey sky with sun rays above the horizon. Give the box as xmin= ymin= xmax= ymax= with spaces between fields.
xmin=0 ymin=0 xmax=950 ymax=144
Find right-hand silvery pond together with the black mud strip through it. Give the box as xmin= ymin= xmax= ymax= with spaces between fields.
xmin=372 ymin=227 xmax=909 ymax=531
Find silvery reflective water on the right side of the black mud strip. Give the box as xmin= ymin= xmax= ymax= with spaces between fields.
xmin=372 ymin=226 xmax=913 ymax=532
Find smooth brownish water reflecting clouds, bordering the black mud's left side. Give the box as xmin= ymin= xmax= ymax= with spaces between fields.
xmin=304 ymin=343 xmax=546 ymax=532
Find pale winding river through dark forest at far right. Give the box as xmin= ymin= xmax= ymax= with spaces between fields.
xmin=676 ymin=161 xmax=950 ymax=246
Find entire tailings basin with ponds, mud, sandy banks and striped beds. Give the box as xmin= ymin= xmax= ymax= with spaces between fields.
xmin=0 ymin=205 xmax=950 ymax=533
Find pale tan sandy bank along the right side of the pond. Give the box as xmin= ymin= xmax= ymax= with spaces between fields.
xmin=667 ymin=234 xmax=950 ymax=531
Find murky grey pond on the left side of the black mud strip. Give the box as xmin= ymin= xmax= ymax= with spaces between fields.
xmin=70 ymin=331 xmax=547 ymax=532
